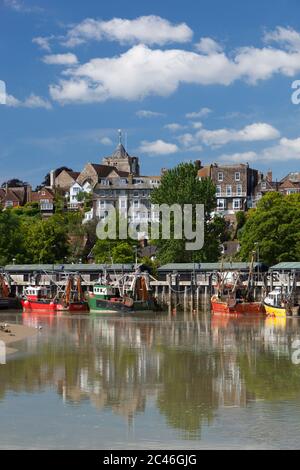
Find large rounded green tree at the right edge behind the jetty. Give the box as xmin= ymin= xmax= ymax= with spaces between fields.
xmin=240 ymin=192 xmax=300 ymax=265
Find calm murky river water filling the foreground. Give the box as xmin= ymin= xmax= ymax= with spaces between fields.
xmin=0 ymin=312 xmax=300 ymax=449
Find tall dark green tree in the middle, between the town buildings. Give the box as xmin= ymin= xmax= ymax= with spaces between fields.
xmin=151 ymin=163 xmax=226 ymax=263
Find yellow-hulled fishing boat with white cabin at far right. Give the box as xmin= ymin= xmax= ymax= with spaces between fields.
xmin=264 ymin=287 xmax=299 ymax=318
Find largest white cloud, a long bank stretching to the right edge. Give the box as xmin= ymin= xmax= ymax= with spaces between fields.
xmin=50 ymin=26 xmax=300 ymax=105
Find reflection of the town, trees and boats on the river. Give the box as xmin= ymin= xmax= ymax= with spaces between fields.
xmin=0 ymin=314 xmax=300 ymax=448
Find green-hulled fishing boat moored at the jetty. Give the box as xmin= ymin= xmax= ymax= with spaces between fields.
xmin=88 ymin=271 xmax=158 ymax=313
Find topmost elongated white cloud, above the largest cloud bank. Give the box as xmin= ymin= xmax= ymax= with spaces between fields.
xmin=63 ymin=15 xmax=193 ymax=47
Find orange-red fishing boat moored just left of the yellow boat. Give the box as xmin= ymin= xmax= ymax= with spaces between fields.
xmin=211 ymin=260 xmax=265 ymax=315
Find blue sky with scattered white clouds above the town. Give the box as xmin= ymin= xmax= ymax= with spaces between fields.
xmin=0 ymin=0 xmax=300 ymax=185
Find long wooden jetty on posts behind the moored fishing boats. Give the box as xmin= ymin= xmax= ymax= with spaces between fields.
xmin=1 ymin=262 xmax=300 ymax=311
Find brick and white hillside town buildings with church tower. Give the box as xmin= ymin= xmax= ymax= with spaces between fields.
xmin=0 ymin=133 xmax=300 ymax=223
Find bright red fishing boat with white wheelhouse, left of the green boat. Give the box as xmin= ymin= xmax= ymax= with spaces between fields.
xmin=21 ymin=276 xmax=88 ymax=314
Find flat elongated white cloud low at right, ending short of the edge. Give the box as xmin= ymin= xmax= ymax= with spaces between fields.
xmin=196 ymin=122 xmax=280 ymax=146
